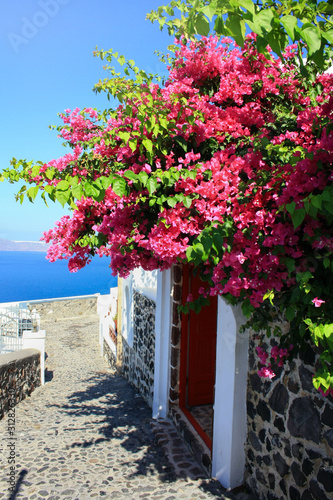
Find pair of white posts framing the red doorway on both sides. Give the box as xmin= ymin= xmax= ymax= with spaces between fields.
xmin=153 ymin=270 xmax=249 ymax=489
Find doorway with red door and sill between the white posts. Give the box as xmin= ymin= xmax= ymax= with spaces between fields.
xmin=179 ymin=265 xmax=217 ymax=449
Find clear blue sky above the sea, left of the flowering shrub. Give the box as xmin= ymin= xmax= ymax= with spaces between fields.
xmin=0 ymin=0 xmax=172 ymax=241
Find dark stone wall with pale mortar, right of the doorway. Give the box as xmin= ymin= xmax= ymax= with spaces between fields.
xmin=245 ymin=340 xmax=333 ymax=500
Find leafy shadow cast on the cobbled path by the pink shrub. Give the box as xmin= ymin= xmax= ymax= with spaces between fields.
xmin=48 ymin=373 xmax=177 ymax=482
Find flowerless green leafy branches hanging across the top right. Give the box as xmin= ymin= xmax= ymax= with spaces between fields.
xmin=147 ymin=0 xmax=333 ymax=74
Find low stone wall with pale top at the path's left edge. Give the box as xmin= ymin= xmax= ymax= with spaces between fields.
xmin=0 ymin=349 xmax=41 ymax=419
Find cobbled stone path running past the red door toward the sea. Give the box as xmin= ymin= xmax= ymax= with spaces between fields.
xmin=0 ymin=306 xmax=252 ymax=500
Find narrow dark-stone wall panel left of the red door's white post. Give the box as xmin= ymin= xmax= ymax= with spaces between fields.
xmin=118 ymin=291 xmax=156 ymax=406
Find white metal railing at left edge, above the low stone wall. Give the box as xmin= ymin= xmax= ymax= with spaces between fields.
xmin=0 ymin=302 xmax=40 ymax=354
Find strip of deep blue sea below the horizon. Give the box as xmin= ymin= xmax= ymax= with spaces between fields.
xmin=0 ymin=252 xmax=117 ymax=303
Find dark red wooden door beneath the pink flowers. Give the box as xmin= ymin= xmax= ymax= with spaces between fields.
xmin=182 ymin=268 xmax=217 ymax=406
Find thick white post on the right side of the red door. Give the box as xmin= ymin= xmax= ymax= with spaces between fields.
xmin=212 ymin=297 xmax=248 ymax=489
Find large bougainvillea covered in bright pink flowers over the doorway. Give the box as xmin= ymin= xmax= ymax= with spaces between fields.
xmin=4 ymin=35 xmax=333 ymax=393
